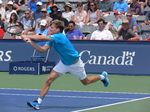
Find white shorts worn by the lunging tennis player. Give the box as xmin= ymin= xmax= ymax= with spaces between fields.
xmin=53 ymin=58 xmax=87 ymax=80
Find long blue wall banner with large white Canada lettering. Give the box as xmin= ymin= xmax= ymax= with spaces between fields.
xmin=0 ymin=40 xmax=150 ymax=75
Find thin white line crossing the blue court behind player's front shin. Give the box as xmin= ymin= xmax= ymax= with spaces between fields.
xmin=0 ymin=93 xmax=133 ymax=100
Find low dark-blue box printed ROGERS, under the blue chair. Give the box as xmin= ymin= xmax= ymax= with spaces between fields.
xmin=9 ymin=61 xmax=55 ymax=75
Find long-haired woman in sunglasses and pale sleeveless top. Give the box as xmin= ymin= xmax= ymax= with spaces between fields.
xmin=85 ymin=2 xmax=101 ymax=26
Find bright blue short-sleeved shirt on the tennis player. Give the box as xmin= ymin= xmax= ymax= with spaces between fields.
xmin=46 ymin=33 xmax=80 ymax=65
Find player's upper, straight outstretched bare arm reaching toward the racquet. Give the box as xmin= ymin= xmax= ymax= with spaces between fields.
xmin=21 ymin=35 xmax=53 ymax=41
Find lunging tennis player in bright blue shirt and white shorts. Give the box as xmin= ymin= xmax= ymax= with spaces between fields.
xmin=21 ymin=20 xmax=109 ymax=110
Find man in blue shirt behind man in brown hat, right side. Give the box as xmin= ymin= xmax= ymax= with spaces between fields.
xmin=126 ymin=12 xmax=137 ymax=33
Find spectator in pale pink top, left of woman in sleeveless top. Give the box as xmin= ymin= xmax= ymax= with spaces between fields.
xmin=72 ymin=2 xmax=87 ymax=28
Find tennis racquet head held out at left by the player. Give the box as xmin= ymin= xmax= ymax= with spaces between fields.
xmin=6 ymin=25 xmax=23 ymax=36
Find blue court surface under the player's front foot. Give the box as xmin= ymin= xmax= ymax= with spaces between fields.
xmin=0 ymin=89 xmax=150 ymax=112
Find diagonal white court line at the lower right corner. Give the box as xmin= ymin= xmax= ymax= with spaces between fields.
xmin=72 ymin=96 xmax=150 ymax=112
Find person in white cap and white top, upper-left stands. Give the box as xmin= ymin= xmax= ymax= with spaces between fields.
xmin=5 ymin=1 xmax=17 ymax=24
